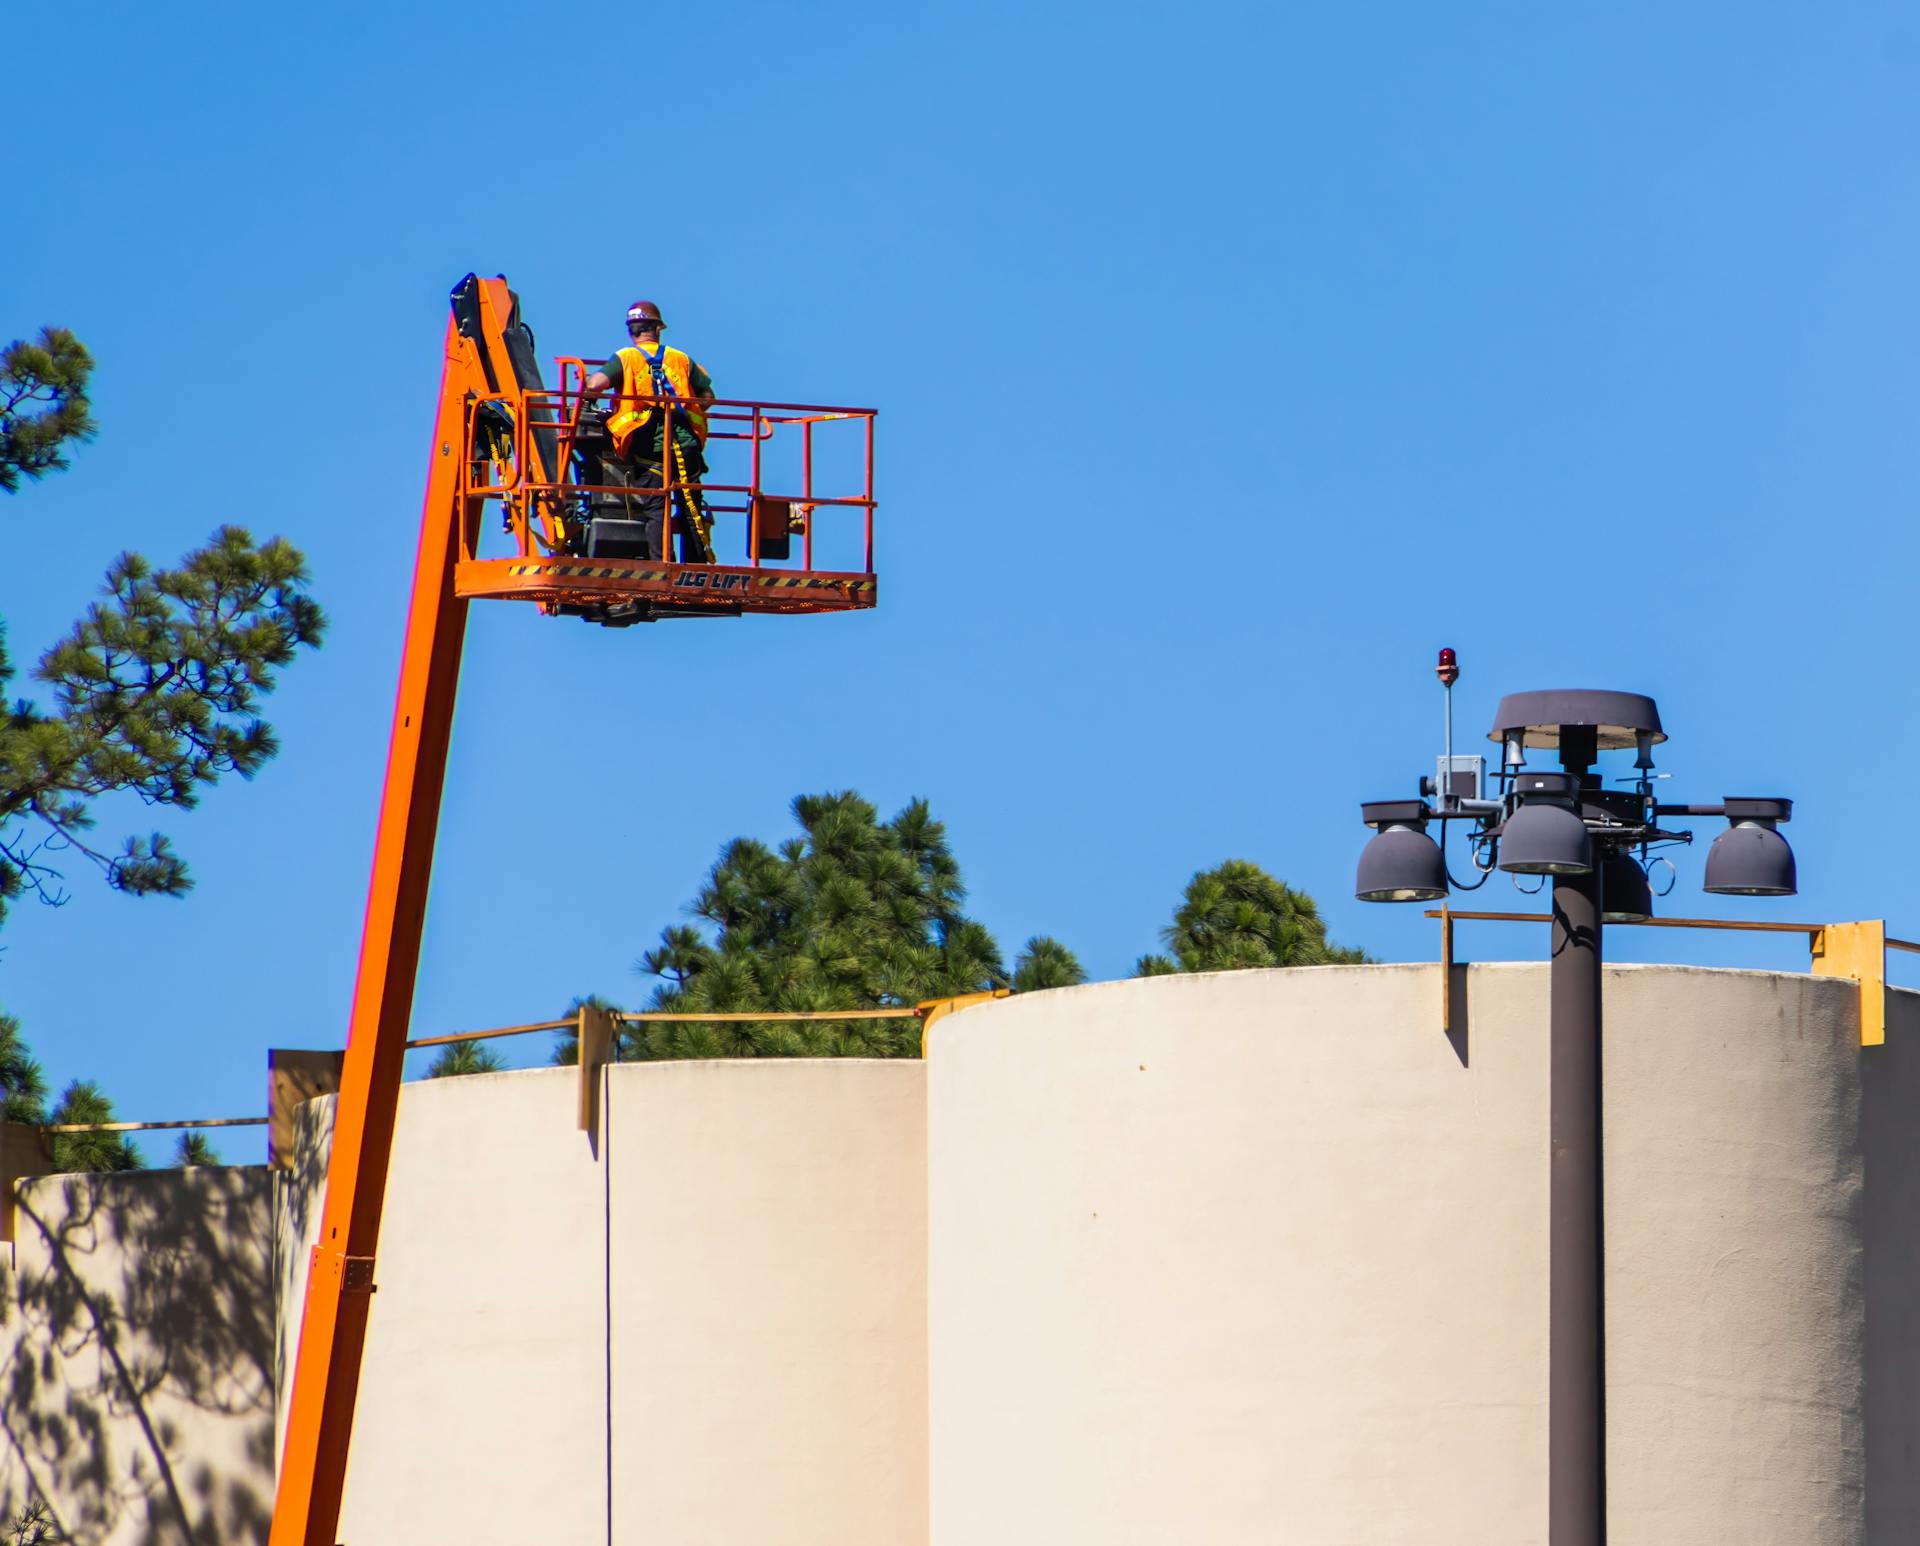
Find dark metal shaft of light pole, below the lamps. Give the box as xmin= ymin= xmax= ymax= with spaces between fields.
xmin=1548 ymin=726 xmax=1607 ymax=1546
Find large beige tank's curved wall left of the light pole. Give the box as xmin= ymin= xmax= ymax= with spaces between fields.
xmin=927 ymin=968 xmax=1546 ymax=1546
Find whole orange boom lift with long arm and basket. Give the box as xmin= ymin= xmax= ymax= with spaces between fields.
xmin=269 ymin=275 xmax=876 ymax=1546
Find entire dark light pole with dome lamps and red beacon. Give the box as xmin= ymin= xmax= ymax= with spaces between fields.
xmin=1354 ymin=649 xmax=1795 ymax=1546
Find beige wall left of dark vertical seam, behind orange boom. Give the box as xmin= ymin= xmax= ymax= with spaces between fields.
xmin=282 ymin=1068 xmax=607 ymax=1546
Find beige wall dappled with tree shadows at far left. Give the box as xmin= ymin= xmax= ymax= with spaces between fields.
xmin=0 ymin=1168 xmax=275 ymax=1546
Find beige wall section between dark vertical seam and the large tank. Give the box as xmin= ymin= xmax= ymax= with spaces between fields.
xmin=609 ymin=1060 xmax=927 ymax=1546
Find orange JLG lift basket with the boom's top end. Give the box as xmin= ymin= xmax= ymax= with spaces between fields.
xmin=440 ymin=275 xmax=877 ymax=624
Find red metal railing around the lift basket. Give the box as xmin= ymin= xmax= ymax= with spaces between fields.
xmin=461 ymin=355 xmax=876 ymax=574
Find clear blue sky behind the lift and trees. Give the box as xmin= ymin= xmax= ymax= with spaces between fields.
xmin=0 ymin=2 xmax=1920 ymax=1158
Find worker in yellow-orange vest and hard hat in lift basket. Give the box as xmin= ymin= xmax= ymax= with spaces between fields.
xmin=586 ymin=302 xmax=714 ymax=563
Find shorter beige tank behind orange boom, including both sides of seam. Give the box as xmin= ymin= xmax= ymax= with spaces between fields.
xmin=282 ymin=1060 xmax=927 ymax=1546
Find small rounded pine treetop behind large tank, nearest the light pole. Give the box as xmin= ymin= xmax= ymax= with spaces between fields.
xmin=1135 ymin=858 xmax=1367 ymax=978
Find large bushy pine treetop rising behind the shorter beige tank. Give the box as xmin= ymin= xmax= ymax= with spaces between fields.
xmin=622 ymin=791 xmax=1085 ymax=1058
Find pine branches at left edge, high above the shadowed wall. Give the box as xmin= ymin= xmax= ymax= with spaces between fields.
xmin=0 ymin=328 xmax=326 ymax=918
